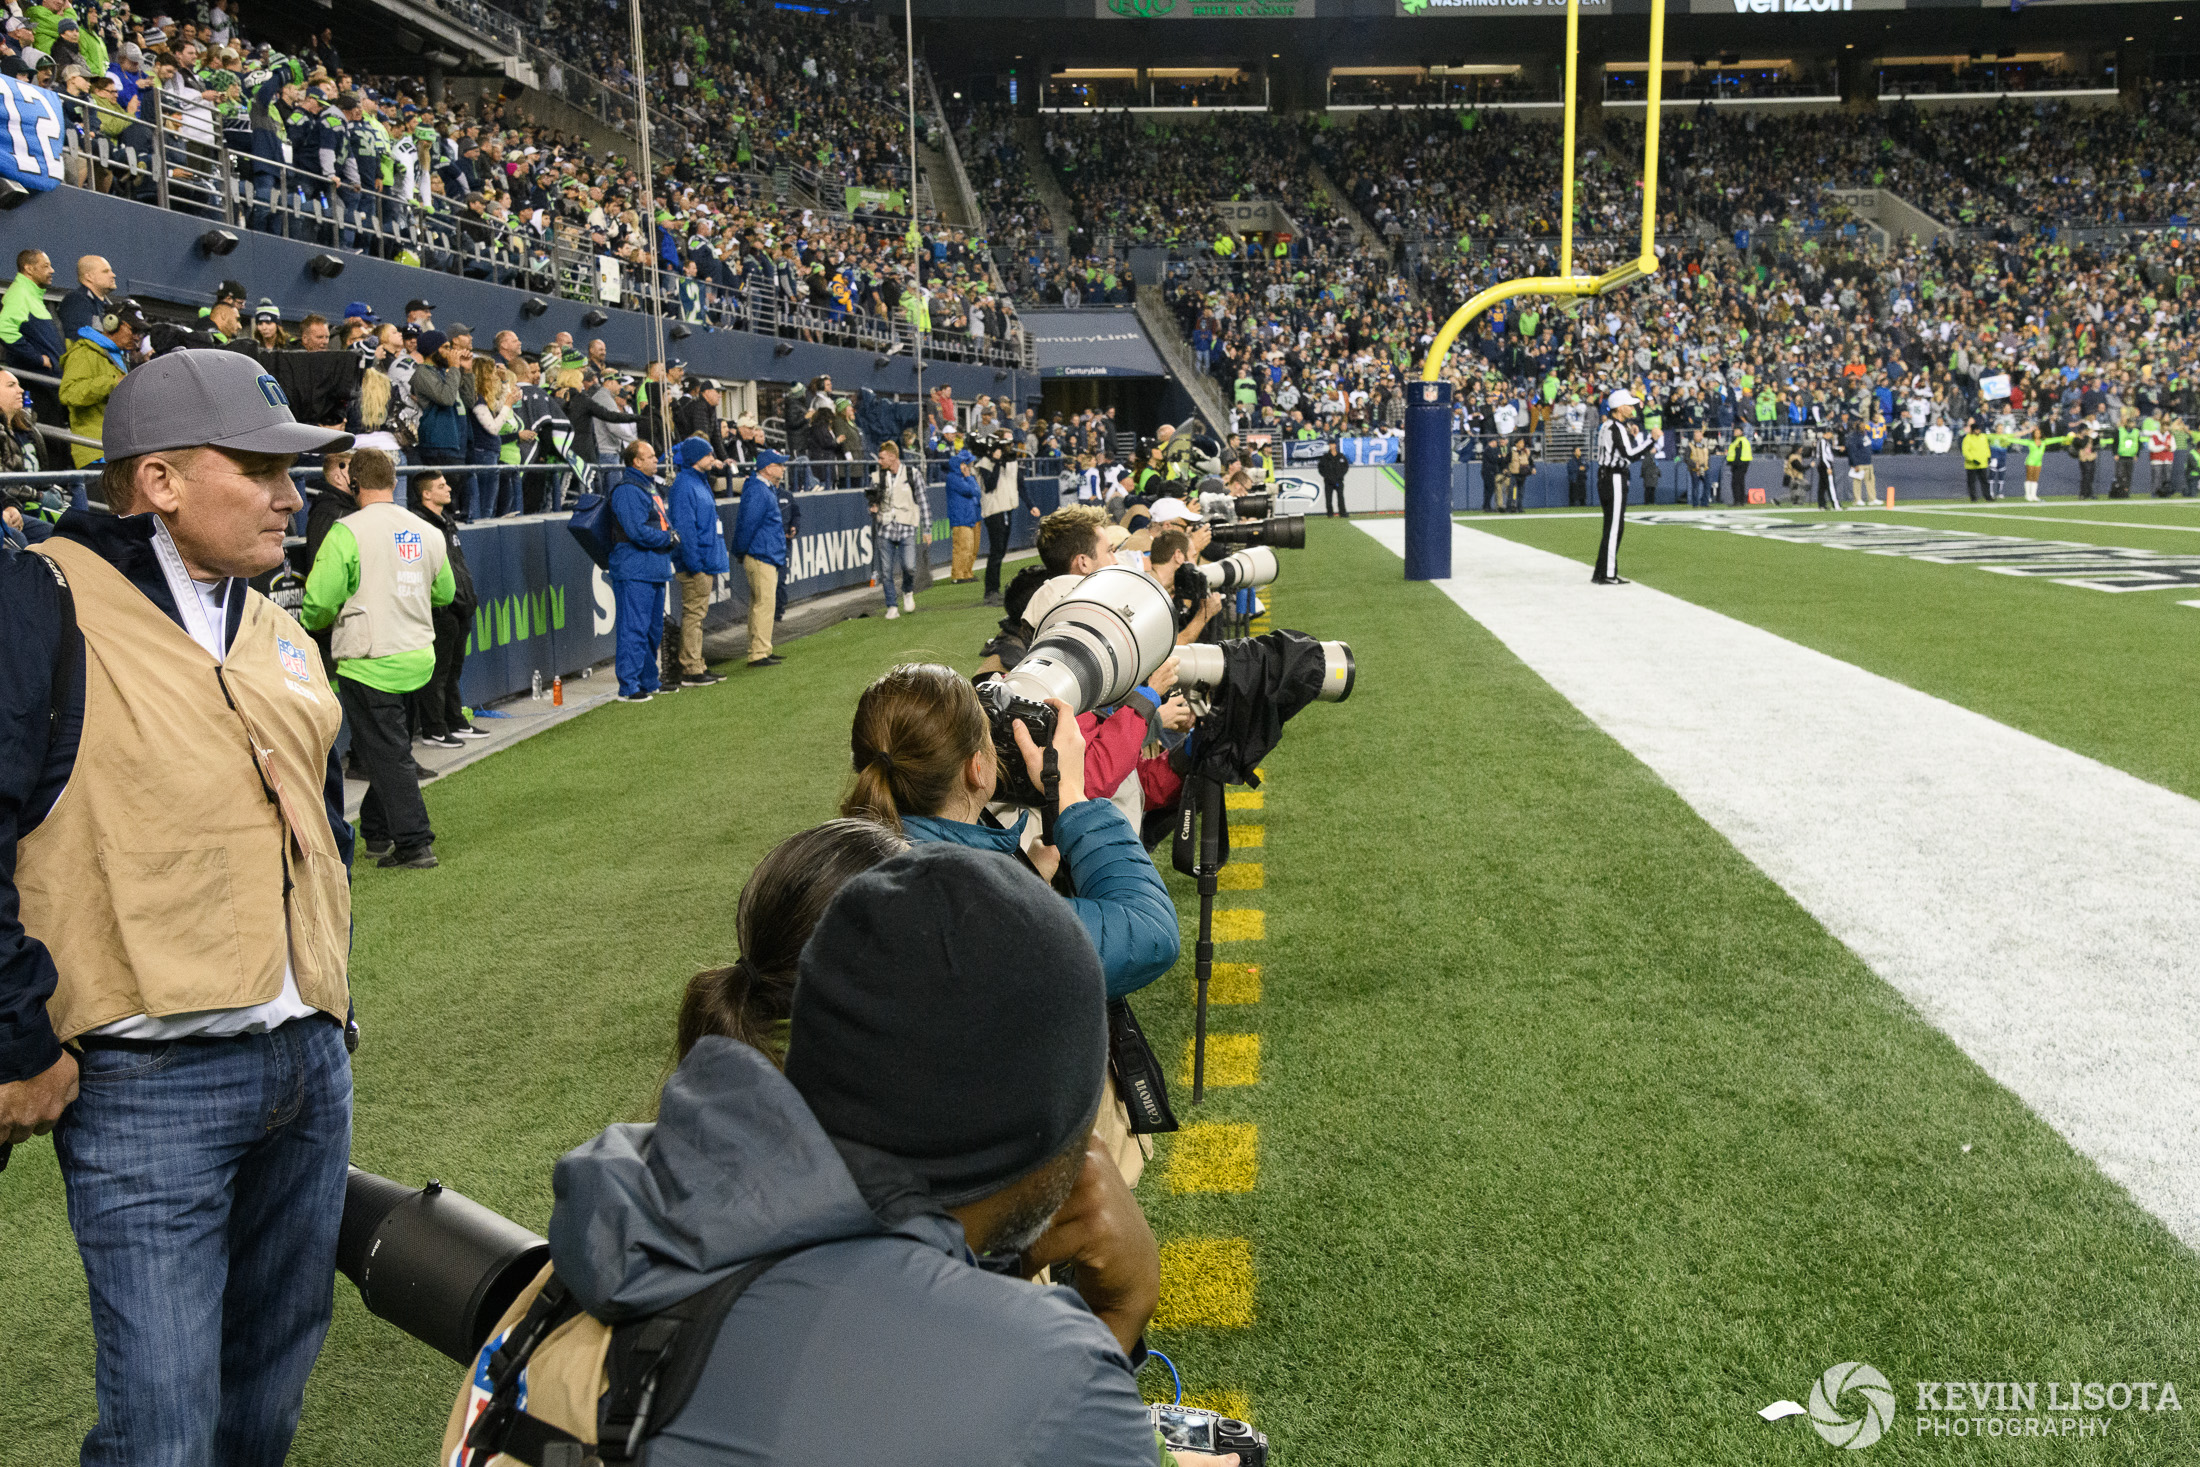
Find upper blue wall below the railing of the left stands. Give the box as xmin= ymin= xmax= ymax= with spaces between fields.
xmin=0 ymin=187 xmax=1038 ymax=402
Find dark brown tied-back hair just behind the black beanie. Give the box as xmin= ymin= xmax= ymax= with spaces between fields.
xmin=678 ymin=820 xmax=909 ymax=1065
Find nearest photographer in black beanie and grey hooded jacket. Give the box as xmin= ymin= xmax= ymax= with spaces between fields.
xmin=451 ymin=845 xmax=1236 ymax=1467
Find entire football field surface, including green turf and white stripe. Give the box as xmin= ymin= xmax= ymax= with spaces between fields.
xmin=0 ymin=510 xmax=2200 ymax=1467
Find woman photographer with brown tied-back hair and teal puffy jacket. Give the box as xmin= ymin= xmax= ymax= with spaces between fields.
xmin=840 ymin=662 xmax=1179 ymax=999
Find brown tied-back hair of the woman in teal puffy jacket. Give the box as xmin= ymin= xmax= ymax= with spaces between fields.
xmin=840 ymin=662 xmax=992 ymax=829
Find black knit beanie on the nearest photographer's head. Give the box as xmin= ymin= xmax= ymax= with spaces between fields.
xmin=788 ymin=842 xmax=1107 ymax=1207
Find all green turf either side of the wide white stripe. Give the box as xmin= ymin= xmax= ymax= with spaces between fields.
xmin=0 ymin=517 xmax=2200 ymax=1467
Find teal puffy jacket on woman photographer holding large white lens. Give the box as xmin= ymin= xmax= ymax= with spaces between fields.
xmin=902 ymin=801 xmax=1181 ymax=999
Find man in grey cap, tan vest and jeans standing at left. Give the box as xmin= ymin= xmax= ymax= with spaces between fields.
xmin=0 ymin=350 xmax=352 ymax=1467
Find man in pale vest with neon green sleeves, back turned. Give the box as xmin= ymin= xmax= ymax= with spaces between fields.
xmin=299 ymin=449 xmax=458 ymax=871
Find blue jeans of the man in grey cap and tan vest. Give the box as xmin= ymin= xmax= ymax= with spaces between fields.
xmin=53 ymin=1016 xmax=352 ymax=1467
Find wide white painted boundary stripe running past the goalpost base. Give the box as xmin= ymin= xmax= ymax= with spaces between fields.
xmin=1360 ymin=521 xmax=2200 ymax=1247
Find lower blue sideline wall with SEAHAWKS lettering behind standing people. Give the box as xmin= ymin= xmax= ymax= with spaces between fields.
xmin=458 ymin=484 xmax=1052 ymax=706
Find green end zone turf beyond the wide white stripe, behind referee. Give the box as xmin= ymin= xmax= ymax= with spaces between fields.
xmin=1461 ymin=499 xmax=2200 ymax=796
